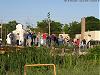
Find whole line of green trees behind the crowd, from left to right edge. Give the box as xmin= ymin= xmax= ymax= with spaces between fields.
xmin=2 ymin=16 xmax=100 ymax=42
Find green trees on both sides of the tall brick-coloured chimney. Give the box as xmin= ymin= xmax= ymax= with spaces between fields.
xmin=63 ymin=16 xmax=100 ymax=38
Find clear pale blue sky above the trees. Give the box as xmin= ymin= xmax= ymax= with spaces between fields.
xmin=0 ymin=0 xmax=100 ymax=27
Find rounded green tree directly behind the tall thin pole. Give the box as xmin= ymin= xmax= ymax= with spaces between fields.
xmin=37 ymin=20 xmax=62 ymax=34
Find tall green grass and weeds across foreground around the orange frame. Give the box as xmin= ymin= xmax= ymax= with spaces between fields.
xmin=0 ymin=46 xmax=100 ymax=75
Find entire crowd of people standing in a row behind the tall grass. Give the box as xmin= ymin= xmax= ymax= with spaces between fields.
xmin=9 ymin=32 xmax=86 ymax=47
